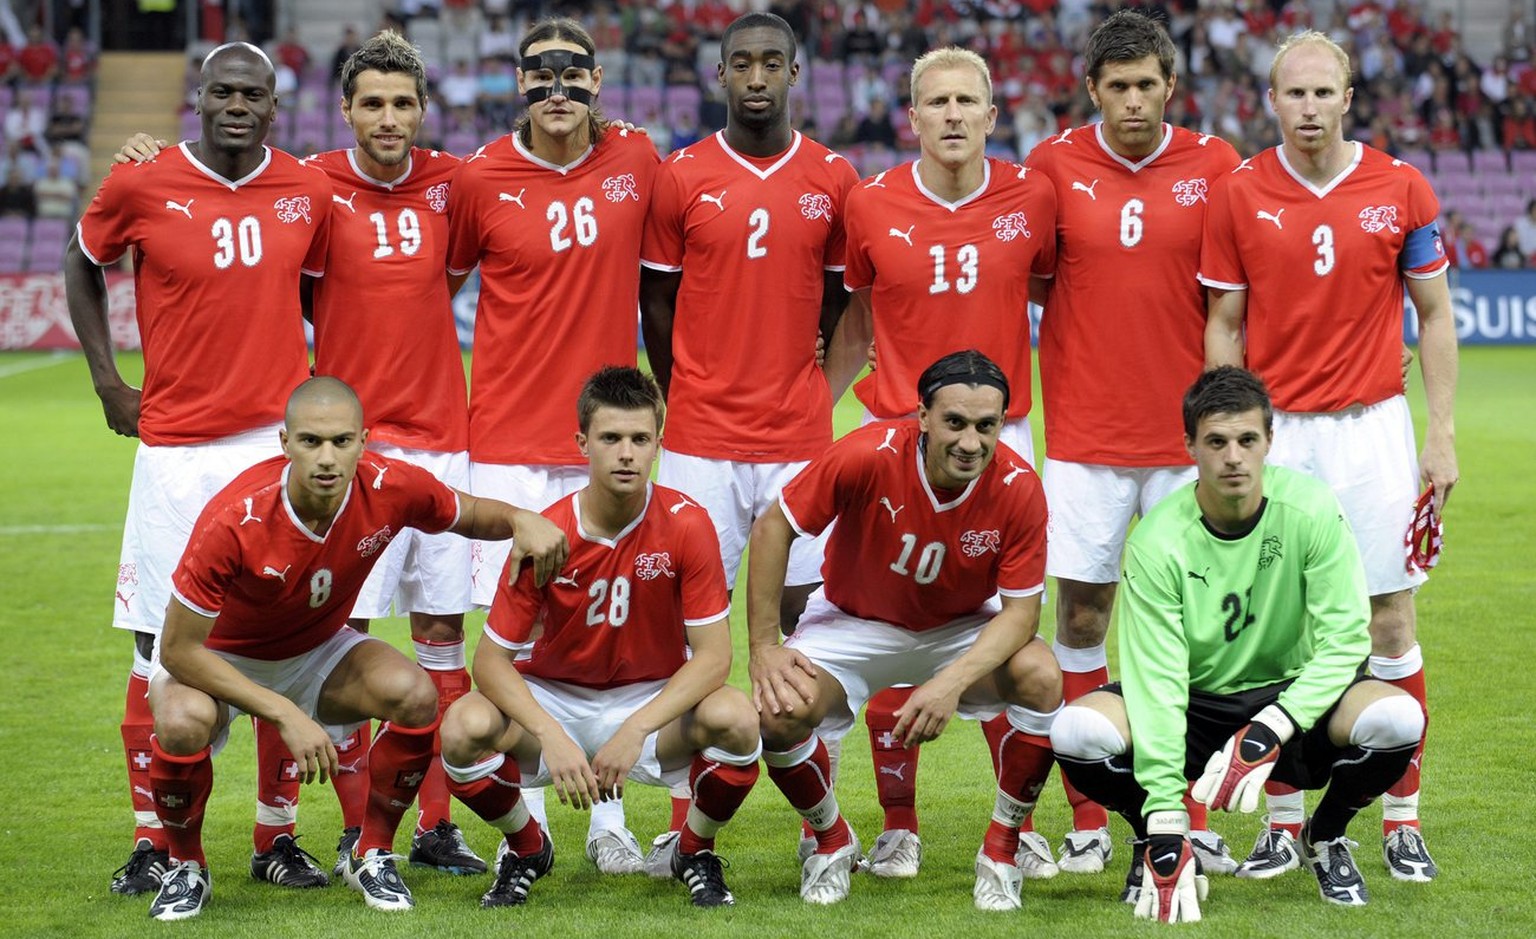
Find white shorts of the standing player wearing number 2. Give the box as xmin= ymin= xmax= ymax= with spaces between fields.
xmin=656 ymin=449 xmax=831 ymax=590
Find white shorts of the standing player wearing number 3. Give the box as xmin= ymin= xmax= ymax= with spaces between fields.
xmin=1269 ymin=395 xmax=1428 ymax=596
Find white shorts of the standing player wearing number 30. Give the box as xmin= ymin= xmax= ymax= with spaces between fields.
xmin=112 ymin=424 xmax=283 ymax=636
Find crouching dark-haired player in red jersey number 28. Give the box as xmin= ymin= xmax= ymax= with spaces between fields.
xmin=442 ymin=366 xmax=760 ymax=907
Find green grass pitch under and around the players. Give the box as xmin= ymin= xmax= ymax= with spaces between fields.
xmin=0 ymin=347 xmax=1536 ymax=939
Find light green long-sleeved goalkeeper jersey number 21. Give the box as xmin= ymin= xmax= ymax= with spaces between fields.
xmin=1120 ymin=466 xmax=1370 ymax=813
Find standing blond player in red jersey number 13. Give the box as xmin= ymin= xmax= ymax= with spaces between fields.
xmin=828 ymin=48 xmax=1057 ymax=878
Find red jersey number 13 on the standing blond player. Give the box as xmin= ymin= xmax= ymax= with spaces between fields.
xmin=845 ymin=158 xmax=1057 ymax=418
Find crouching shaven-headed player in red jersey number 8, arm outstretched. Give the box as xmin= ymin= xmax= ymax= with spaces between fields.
xmin=139 ymin=377 xmax=567 ymax=921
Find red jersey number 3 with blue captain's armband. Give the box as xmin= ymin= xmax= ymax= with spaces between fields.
xmin=1200 ymin=143 xmax=1447 ymax=413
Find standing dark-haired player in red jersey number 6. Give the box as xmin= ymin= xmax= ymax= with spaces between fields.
xmin=1020 ymin=9 xmax=1238 ymax=876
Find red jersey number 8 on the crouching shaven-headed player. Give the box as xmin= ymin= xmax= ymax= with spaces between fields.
xmin=170 ymin=453 xmax=459 ymax=661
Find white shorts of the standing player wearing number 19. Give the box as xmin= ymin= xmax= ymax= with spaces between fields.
xmin=352 ymin=444 xmax=473 ymax=619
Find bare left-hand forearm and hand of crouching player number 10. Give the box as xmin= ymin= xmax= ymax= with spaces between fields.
xmin=746 ymin=503 xmax=816 ymax=715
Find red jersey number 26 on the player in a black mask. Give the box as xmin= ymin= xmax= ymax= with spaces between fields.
xmin=449 ymin=128 xmax=660 ymax=466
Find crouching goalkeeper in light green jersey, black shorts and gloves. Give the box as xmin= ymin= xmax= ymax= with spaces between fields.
xmin=1051 ymin=366 xmax=1424 ymax=922
